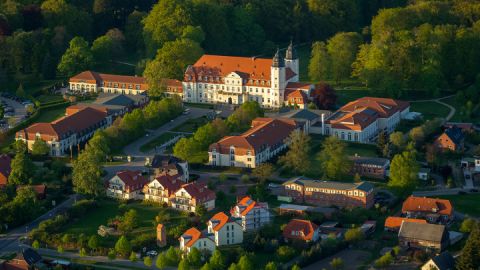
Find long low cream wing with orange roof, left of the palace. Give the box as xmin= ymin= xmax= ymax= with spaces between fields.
xmin=69 ymin=70 xmax=148 ymax=95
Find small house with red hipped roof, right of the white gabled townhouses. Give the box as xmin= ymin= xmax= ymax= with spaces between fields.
xmin=282 ymin=219 xmax=320 ymax=243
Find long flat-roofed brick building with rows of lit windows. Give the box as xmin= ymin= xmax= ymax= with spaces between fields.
xmin=283 ymin=177 xmax=374 ymax=208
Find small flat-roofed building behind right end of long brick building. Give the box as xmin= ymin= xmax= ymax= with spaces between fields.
xmin=351 ymin=156 xmax=390 ymax=179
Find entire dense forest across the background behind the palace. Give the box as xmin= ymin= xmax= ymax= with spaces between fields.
xmin=0 ymin=0 xmax=480 ymax=100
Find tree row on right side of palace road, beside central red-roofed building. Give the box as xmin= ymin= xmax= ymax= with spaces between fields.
xmin=173 ymin=101 xmax=264 ymax=163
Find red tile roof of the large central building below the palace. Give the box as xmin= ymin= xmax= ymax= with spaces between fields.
xmin=209 ymin=118 xmax=298 ymax=155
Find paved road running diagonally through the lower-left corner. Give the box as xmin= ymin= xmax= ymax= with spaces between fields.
xmin=0 ymin=194 xmax=79 ymax=254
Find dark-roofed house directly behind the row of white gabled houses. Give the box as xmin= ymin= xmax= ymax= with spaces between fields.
xmin=150 ymin=155 xmax=190 ymax=182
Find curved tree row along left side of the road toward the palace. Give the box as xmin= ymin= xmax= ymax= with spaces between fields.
xmin=72 ymin=96 xmax=183 ymax=196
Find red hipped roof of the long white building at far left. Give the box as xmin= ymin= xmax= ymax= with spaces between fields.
xmin=17 ymin=107 xmax=107 ymax=141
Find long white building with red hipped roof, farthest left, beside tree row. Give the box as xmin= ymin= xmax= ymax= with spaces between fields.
xmin=15 ymin=107 xmax=112 ymax=156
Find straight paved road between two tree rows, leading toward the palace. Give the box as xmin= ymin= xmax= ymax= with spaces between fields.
xmin=123 ymin=107 xmax=212 ymax=156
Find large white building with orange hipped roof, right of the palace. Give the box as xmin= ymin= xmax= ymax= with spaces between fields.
xmin=322 ymin=97 xmax=410 ymax=143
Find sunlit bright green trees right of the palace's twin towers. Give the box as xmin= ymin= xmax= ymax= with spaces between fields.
xmin=309 ymin=0 xmax=480 ymax=97
